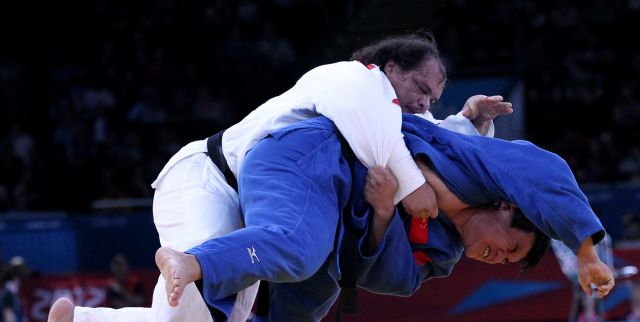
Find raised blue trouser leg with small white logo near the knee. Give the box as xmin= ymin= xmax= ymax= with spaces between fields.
xmin=188 ymin=125 xmax=351 ymax=319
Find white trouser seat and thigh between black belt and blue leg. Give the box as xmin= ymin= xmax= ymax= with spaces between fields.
xmin=153 ymin=142 xmax=244 ymax=251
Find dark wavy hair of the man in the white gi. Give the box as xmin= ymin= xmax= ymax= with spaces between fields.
xmin=351 ymin=31 xmax=447 ymax=79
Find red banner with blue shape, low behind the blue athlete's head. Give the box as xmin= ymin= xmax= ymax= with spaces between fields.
xmin=323 ymin=248 xmax=640 ymax=322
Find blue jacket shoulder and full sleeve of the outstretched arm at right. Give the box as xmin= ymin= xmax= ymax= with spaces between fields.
xmin=403 ymin=114 xmax=605 ymax=253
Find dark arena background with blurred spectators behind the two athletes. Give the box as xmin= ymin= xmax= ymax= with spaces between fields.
xmin=0 ymin=0 xmax=640 ymax=321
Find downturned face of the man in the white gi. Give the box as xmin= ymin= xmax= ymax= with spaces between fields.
xmin=384 ymin=59 xmax=444 ymax=113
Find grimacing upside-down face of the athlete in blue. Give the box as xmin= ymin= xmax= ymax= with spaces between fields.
xmin=461 ymin=203 xmax=534 ymax=264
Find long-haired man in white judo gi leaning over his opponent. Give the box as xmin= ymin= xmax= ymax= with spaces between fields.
xmin=49 ymin=35 xmax=512 ymax=322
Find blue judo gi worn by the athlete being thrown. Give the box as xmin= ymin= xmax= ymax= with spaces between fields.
xmin=187 ymin=114 xmax=604 ymax=321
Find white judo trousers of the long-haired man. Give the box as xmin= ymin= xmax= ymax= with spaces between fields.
xmin=73 ymin=140 xmax=258 ymax=322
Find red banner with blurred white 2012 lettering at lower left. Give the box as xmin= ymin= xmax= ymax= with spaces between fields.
xmin=20 ymin=270 xmax=159 ymax=322
